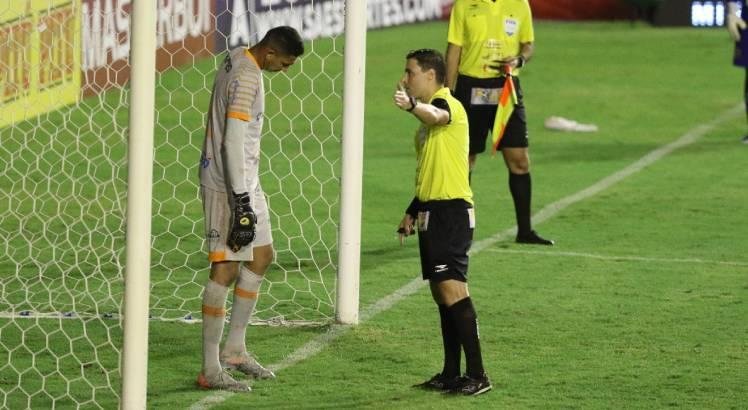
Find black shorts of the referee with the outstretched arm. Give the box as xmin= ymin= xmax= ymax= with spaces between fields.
xmin=416 ymin=199 xmax=475 ymax=282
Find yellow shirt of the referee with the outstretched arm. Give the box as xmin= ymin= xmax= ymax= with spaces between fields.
xmin=415 ymin=87 xmax=473 ymax=204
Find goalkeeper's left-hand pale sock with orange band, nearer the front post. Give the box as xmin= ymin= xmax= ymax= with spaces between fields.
xmin=203 ymin=280 xmax=229 ymax=375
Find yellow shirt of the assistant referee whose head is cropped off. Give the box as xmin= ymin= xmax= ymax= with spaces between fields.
xmin=447 ymin=0 xmax=535 ymax=78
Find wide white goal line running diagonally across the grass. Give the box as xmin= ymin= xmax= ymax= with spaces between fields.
xmin=190 ymin=104 xmax=744 ymax=410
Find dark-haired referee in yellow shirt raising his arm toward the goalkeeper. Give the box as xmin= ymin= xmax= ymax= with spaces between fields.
xmin=394 ymin=49 xmax=491 ymax=395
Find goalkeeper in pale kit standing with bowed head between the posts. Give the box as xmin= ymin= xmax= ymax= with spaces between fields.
xmin=197 ymin=26 xmax=304 ymax=391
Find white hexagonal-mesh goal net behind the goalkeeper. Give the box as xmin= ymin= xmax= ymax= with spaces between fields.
xmin=0 ymin=0 xmax=343 ymax=408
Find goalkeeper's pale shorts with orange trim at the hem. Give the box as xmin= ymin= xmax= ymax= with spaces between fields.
xmin=200 ymin=186 xmax=273 ymax=262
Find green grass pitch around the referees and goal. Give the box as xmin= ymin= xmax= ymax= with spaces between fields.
xmin=0 ymin=22 xmax=748 ymax=409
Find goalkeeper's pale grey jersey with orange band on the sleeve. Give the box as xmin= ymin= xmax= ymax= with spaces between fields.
xmin=200 ymin=47 xmax=265 ymax=192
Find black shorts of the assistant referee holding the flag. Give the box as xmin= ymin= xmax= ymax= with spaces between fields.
xmin=455 ymin=75 xmax=530 ymax=155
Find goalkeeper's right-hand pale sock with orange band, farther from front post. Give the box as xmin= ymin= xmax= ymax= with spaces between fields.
xmin=223 ymin=265 xmax=263 ymax=354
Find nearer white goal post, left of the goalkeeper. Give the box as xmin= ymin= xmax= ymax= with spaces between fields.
xmin=120 ymin=0 xmax=156 ymax=410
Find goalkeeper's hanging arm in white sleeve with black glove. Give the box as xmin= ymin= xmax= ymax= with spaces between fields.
xmin=223 ymin=118 xmax=257 ymax=252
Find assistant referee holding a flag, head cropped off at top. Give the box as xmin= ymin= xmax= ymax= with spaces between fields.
xmin=446 ymin=0 xmax=553 ymax=245
